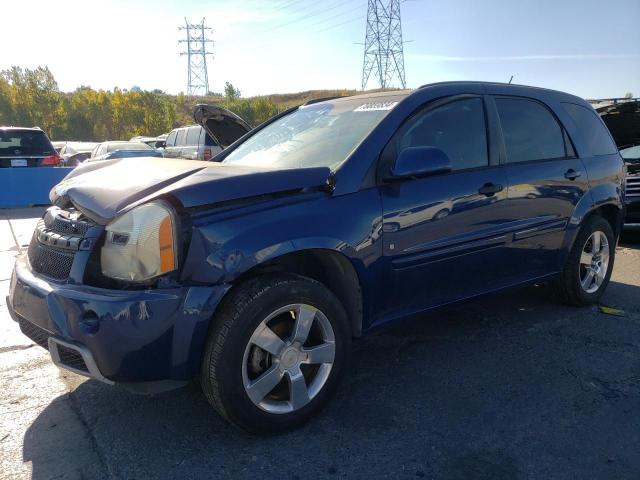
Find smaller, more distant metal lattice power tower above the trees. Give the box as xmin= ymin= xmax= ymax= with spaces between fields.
xmin=180 ymin=18 xmax=213 ymax=95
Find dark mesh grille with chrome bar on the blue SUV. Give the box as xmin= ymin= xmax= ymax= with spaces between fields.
xmin=27 ymin=207 xmax=93 ymax=280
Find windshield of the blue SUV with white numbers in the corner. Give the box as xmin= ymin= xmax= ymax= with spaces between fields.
xmin=224 ymin=98 xmax=397 ymax=169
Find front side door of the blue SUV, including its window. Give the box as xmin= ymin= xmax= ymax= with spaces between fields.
xmin=380 ymin=95 xmax=508 ymax=314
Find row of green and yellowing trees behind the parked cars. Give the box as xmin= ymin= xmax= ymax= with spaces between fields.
xmin=0 ymin=67 xmax=288 ymax=141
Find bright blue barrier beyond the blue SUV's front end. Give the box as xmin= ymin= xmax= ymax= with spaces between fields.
xmin=0 ymin=167 xmax=73 ymax=208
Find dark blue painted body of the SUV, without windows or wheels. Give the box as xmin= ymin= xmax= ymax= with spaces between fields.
xmin=5 ymin=83 xmax=623 ymax=382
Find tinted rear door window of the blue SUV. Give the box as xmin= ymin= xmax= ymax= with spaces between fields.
xmin=496 ymin=98 xmax=566 ymax=163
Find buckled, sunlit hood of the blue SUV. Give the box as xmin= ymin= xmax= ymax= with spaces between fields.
xmin=49 ymin=157 xmax=331 ymax=224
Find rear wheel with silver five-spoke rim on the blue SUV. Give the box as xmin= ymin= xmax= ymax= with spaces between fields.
xmin=558 ymin=215 xmax=616 ymax=305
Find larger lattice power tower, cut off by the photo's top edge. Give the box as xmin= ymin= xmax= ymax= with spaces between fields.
xmin=362 ymin=0 xmax=406 ymax=90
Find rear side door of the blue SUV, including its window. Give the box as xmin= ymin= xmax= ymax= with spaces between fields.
xmin=493 ymin=95 xmax=588 ymax=281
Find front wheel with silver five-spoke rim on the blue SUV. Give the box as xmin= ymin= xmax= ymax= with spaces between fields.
xmin=201 ymin=275 xmax=351 ymax=433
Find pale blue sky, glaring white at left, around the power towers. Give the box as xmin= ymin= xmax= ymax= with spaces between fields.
xmin=0 ymin=0 xmax=640 ymax=98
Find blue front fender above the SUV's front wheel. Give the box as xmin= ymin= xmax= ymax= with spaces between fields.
xmin=181 ymin=189 xmax=382 ymax=296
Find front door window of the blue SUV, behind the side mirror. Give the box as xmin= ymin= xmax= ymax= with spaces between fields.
xmin=396 ymin=98 xmax=489 ymax=170
